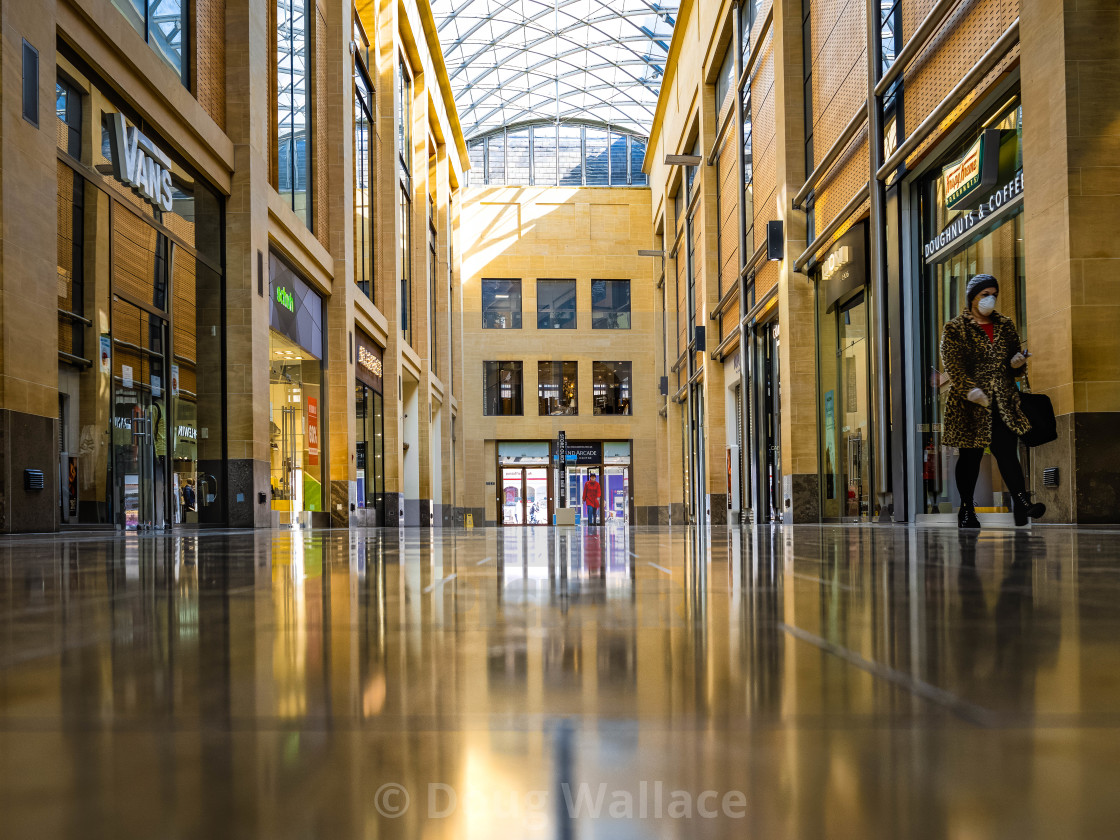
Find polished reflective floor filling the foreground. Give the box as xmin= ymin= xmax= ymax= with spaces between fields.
xmin=0 ymin=526 xmax=1120 ymax=840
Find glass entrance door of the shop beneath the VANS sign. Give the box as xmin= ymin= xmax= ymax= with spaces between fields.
xmin=112 ymin=299 xmax=169 ymax=531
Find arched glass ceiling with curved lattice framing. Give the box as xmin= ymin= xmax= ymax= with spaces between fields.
xmin=431 ymin=0 xmax=679 ymax=139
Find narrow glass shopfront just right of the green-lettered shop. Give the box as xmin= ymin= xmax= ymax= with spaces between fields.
xmin=354 ymin=329 xmax=385 ymax=526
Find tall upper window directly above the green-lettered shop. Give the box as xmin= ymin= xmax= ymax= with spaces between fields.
xmin=276 ymin=0 xmax=311 ymax=227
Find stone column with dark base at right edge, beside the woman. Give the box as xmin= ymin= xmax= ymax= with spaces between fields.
xmin=1020 ymin=0 xmax=1120 ymax=523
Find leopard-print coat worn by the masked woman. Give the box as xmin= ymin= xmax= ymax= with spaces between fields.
xmin=941 ymin=311 xmax=1030 ymax=449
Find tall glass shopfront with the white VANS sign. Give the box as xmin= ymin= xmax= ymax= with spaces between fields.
xmin=56 ymin=54 xmax=225 ymax=530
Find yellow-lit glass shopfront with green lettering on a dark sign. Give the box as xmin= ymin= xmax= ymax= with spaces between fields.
xmin=269 ymin=252 xmax=326 ymax=525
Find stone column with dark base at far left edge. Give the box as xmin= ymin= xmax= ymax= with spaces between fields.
xmin=0 ymin=3 xmax=59 ymax=532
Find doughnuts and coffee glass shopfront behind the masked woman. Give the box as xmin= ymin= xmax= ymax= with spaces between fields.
xmin=918 ymin=94 xmax=1027 ymax=514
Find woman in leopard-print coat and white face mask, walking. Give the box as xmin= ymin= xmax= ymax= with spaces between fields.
xmin=941 ymin=274 xmax=1046 ymax=528
